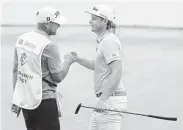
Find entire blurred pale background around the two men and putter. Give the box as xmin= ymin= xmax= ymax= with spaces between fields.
xmin=0 ymin=0 xmax=183 ymax=130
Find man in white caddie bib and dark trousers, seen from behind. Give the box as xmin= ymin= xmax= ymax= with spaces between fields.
xmin=12 ymin=7 xmax=74 ymax=130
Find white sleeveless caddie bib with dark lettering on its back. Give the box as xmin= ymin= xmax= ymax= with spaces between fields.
xmin=12 ymin=31 xmax=52 ymax=109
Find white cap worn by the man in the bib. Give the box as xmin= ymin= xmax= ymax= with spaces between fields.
xmin=36 ymin=7 xmax=67 ymax=24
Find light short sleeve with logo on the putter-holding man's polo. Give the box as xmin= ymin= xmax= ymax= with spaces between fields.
xmin=102 ymin=38 xmax=121 ymax=64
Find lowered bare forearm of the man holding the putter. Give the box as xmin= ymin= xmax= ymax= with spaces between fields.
xmin=100 ymin=71 xmax=122 ymax=101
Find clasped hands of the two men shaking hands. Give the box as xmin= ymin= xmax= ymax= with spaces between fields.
xmin=64 ymin=52 xmax=78 ymax=64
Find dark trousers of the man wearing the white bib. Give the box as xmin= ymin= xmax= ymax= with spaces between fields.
xmin=22 ymin=99 xmax=60 ymax=130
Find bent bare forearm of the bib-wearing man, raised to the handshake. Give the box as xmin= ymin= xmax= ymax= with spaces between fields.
xmin=61 ymin=60 xmax=72 ymax=81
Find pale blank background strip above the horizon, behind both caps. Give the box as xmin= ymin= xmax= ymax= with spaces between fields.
xmin=1 ymin=0 xmax=183 ymax=28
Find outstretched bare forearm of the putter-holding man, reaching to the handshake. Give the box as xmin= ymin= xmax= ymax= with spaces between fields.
xmin=76 ymin=57 xmax=95 ymax=70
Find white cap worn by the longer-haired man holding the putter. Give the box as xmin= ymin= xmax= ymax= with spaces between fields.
xmin=85 ymin=5 xmax=115 ymax=22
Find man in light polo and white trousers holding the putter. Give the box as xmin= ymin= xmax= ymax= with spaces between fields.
xmin=67 ymin=5 xmax=127 ymax=130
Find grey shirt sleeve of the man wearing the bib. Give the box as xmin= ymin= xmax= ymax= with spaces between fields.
xmin=46 ymin=44 xmax=62 ymax=73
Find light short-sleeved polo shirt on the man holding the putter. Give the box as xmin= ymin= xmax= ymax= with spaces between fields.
xmin=94 ymin=31 xmax=125 ymax=94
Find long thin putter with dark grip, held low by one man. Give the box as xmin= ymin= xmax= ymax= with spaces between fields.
xmin=75 ymin=103 xmax=177 ymax=121
